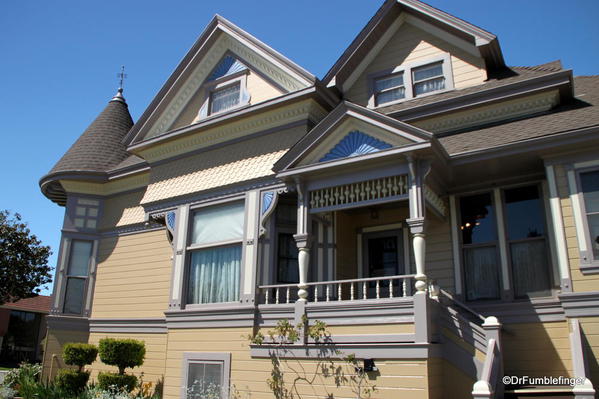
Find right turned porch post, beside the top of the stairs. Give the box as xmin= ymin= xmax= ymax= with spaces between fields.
xmin=406 ymin=156 xmax=428 ymax=292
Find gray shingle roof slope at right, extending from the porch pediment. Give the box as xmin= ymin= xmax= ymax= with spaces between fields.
xmin=439 ymin=76 xmax=599 ymax=155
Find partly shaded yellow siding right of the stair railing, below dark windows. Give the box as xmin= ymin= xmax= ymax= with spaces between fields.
xmin=502 ymin=321 xmax=572 ymax=377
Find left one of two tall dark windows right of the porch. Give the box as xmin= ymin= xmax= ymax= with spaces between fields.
xmin=460 ymin=193 xmax=501 ymax=301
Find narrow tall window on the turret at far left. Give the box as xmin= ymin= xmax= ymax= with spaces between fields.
xmin=63 ymin=240 xmax=93 ymax=315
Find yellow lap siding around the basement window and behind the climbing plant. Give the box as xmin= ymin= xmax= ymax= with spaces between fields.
xmin=164 ymin=326 xmax=428 ymax=399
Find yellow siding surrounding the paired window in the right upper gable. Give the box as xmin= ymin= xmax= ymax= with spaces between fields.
xmin=346 ymin=23 xmax=487 ymax=105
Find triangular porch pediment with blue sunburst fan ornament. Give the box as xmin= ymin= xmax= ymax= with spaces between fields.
xmin=274 ymin=102 xmax=432 ymax=172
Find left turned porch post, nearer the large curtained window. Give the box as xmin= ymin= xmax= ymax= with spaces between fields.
xmin=293 ymin=178 xmax=312 ymax=302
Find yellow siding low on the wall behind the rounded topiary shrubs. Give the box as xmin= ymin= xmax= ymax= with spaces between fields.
xmin=89 ymin=333 xmax=167 ymax=384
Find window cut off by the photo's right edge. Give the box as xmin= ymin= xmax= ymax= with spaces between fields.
xmin=579 ymin=170 xmax=599 ymax=261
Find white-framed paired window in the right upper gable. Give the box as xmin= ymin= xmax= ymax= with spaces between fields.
xmin=368 ymin=54 xmax=453 ymax=108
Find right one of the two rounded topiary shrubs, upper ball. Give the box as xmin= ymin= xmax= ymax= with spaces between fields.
xmin=99 ymin=338 xmax=146 ymax=375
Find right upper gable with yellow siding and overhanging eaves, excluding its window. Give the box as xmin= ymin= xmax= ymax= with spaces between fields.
xmin=344 ymin=15 xmax=487 ymax=106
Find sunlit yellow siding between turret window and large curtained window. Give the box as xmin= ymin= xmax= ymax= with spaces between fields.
xmin=92 ymin=230 xmax=173 ymax=318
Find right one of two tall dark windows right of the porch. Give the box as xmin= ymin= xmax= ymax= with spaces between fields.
xmin=504 ymin=185 xmax=551 ymax=298
